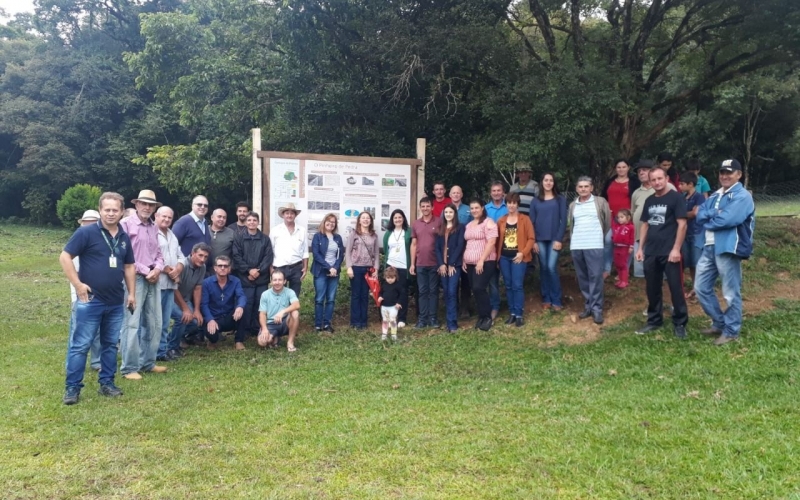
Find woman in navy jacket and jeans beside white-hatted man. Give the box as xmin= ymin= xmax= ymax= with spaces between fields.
xmin=311 ymin=214 xmax=344 ymax=333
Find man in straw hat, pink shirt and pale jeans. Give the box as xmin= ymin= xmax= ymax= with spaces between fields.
xmin=119 ymin=189 xmax=167 ymax=380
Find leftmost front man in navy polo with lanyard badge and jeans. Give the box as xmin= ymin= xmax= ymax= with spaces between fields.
xmin=58 ymin=193 xmax=136 ymax=405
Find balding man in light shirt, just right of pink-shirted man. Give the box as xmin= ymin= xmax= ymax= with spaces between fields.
xmin=156 ymin=206 xmax=185 ymax=361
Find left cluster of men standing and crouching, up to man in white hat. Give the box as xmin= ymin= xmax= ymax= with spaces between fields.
xmin=59 ymin=190 xmax=308 ymax=404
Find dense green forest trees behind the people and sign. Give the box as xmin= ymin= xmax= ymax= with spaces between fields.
xmin=0 ymin=0 xmax=800 ymax=223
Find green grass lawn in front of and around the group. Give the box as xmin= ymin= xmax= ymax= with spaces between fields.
xmin=0 ymin=224 xmax=800 ymax=499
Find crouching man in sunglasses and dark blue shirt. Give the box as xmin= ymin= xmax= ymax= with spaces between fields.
xmin=200 ymin=255 xmax=247 ymax=349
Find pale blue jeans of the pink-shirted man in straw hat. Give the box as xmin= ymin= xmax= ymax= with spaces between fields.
xmin=119 ymin=274 xmax=162 ymax=375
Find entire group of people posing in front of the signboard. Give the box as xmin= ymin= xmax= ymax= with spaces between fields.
xmin=60 ymin=153 xmax=754 ymax=404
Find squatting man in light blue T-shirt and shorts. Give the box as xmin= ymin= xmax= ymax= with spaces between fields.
xmin=258 ymin=269 xmax=300 ymax=352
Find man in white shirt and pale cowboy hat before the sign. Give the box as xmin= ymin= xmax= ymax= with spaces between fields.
xmin=269 ymin=203 xmax=308 ymax=297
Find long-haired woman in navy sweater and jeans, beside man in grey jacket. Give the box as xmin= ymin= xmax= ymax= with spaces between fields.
xmin=530 ymin=172 xmax=567 ymax=311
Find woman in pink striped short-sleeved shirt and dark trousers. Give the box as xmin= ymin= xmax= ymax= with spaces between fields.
xmin=463 ymin=198 xmax=497 ymax=331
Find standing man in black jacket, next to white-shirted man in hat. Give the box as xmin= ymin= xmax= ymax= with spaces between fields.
xmin=233 ymin=212 xmax=273 ymax=351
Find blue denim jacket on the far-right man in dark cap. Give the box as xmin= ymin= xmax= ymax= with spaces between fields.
xmin=694 ymin=182 xmax=756 ymax=259
